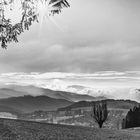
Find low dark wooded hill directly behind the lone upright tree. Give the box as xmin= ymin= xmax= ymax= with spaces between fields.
xmin=58 ymin=99 xmax=140 ymax=111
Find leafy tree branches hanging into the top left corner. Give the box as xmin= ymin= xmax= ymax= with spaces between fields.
xmin=0 ymin=0 xmax=70 ymax=48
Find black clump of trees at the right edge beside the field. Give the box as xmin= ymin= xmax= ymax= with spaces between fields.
xmin=122 ymin=106 xmax=140 ymax=129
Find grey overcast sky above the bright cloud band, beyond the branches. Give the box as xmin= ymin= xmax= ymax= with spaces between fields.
xmin=0 ymin=0 xmax=140 ymax=73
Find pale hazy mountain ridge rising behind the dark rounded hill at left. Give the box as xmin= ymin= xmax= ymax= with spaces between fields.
xmin=3 ymin=85 xmax=105 ymax=102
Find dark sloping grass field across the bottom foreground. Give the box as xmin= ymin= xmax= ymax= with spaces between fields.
xmin=0 ymin=119 xmax=140 ymax=140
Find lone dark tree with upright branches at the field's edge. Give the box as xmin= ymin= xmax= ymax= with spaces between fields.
xmin=92 ymin=101 xmax=108 ymax=128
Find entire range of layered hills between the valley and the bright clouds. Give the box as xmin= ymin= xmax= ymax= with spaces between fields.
xmin=0 ymin=85 xmax=140 ymax=113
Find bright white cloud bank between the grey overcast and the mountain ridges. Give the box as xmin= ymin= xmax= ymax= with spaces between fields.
xmin=0 ymin=71 xmax=140 ymax=101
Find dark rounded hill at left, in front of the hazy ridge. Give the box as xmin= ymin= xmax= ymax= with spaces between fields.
xmin=0 ymin=95 xmax=73 ymax=113
